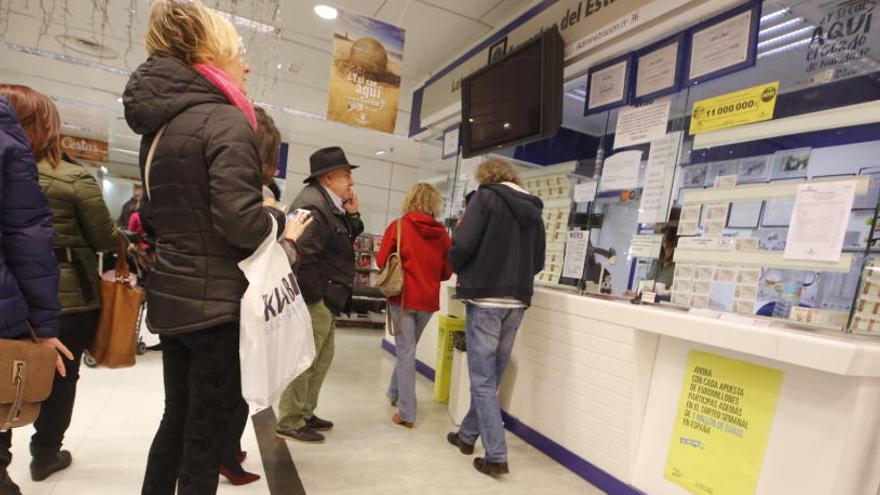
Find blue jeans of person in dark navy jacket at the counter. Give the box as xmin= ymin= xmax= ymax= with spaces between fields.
xmin=458 ymin=304 xmax=526 ymax=462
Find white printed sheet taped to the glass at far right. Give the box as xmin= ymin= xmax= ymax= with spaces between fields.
xmin=785 ymin=180 xmax=856 ymax=262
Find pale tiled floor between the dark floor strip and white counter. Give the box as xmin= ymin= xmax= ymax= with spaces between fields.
xmin=290 ymin=329 xmax=602 ymax=495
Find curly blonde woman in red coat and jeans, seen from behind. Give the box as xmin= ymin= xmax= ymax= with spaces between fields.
xmin=376 ymin=184 xmax=452 ymax=428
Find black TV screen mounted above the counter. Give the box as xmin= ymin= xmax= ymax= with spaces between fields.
xmin=461 ymin=28 xmax=564 ymax=158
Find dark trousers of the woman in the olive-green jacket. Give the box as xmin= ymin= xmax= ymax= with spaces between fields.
xmin=0 ymin=311 xmax=100 ymax=467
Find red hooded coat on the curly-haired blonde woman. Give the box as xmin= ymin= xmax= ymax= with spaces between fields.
xmin=376 ymin=212 xmax=452 ymax=312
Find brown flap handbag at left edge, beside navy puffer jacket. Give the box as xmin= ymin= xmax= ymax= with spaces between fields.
xmin=0 ymin=323 xmax=58 ymax=431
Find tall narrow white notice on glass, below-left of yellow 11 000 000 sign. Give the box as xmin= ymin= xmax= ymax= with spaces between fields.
xmin=639 ymin=131 xmax=684 ymax=223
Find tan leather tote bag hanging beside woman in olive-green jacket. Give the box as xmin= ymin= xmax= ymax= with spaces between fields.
xmin=89 ymin=238 xmax=144 ymax=368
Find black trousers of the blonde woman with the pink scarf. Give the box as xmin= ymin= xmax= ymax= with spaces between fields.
xmin=141 ymin=322 xmax=241 ymax=495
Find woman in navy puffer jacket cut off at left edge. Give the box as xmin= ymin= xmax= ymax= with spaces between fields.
xmin=0 ymin=93 xmax=73 ymax=495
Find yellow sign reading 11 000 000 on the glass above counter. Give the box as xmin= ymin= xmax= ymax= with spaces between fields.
xmin=691 ymin=81 xmax=779 ymax=134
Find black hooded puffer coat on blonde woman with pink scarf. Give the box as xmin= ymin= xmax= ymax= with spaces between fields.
xmin=123 ymin=57 xmax=284 ymax=334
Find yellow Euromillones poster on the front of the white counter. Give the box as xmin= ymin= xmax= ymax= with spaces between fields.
xmin=664 ymin=351 xmax=782 ymax=495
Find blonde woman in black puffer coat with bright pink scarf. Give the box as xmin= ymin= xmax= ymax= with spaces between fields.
xmin=123 ymin=1 xmax=305 ymax=495
